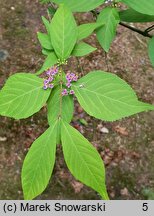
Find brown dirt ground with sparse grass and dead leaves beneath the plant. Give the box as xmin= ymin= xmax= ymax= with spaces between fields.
xmin=0 ymin=0 xmax=154 ymax=200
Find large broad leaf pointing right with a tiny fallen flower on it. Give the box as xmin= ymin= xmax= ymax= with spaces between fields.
xmin=72 ymin=71 xmax=154 ymax=121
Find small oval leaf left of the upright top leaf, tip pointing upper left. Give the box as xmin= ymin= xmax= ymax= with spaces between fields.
xmin=37 ymin=32 xmax=53 ymax=50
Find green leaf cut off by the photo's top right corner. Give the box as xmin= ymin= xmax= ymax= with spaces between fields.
xmin=121 ymin=0 xmax=154 ymax=15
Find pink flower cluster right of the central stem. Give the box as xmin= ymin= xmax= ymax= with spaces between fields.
xmin=62 ymin=73 xmax=78 ymax=96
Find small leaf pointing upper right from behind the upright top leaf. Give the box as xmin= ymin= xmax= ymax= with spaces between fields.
xmin=77 ymin=23 xmax=102 ymax=40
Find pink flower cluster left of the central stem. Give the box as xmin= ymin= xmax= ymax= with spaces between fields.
xmin=43 ymin=66 xmax=58 ymax=90
